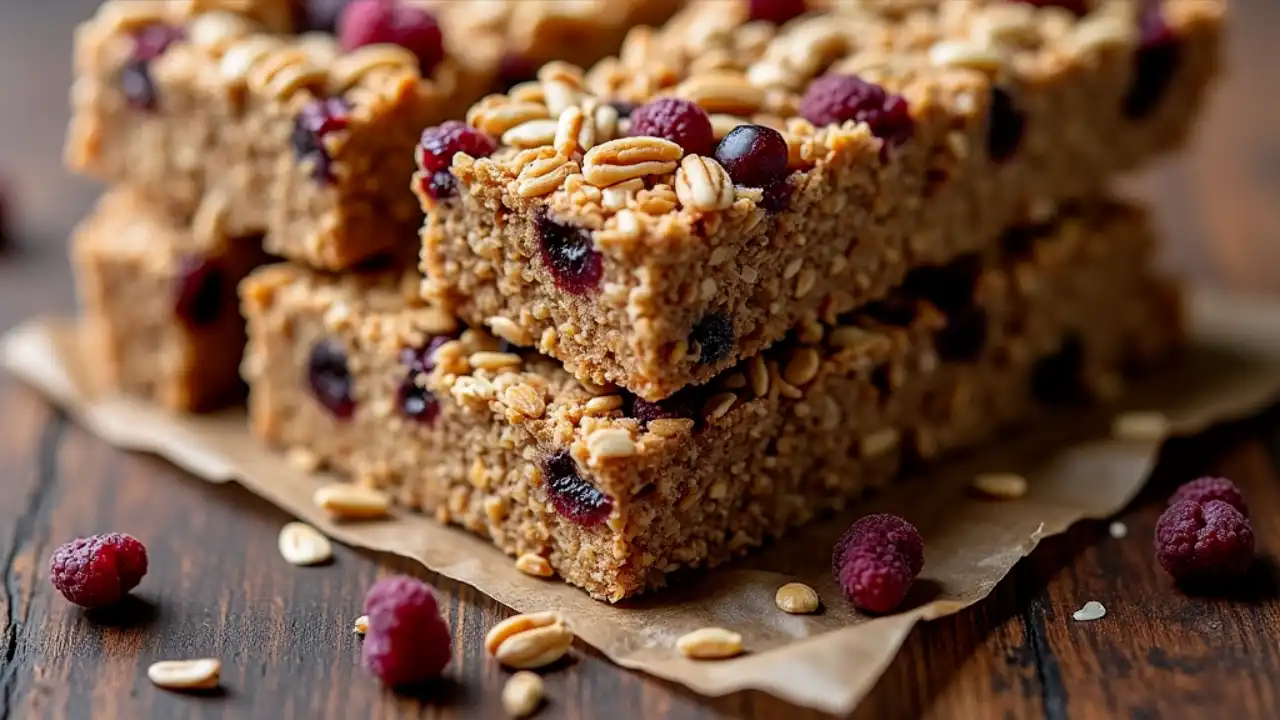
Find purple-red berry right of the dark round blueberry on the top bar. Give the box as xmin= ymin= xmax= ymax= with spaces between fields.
xmin=800 ymin=74 xmax=915 ymax=147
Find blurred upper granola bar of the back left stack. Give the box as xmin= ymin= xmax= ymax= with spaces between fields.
xmin=67 ymin=0 xmax=676 ymax=269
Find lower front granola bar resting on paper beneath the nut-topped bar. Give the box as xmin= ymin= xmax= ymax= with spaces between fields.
xmin=241 ymin=198 xmax=1181 ymax=601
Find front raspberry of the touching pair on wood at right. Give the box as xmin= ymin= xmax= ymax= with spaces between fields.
xmin=1156 ymin=500 xmax=1253 ymax=582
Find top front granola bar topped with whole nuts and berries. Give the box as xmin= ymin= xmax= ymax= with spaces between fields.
xmin=415 ymin=0 xmax=1224 ymax=400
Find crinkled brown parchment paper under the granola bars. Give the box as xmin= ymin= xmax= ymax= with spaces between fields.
xmin=0 ymin=286 xmax=1280 ymax=714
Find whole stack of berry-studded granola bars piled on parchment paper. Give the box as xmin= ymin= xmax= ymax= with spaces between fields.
xmin=64 ymin=0 xmax=1224 ymax=601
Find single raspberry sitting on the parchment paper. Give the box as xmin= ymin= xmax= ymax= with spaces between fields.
xmin=831 ymin=514 xmax=924 ymax=612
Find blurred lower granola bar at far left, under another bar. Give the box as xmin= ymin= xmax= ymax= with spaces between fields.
xmin=72 ymin=190 xmax=268 ymax=411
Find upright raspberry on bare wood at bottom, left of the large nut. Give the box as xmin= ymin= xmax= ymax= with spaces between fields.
xmin=361 ymin=575 xmax=453 ymax=685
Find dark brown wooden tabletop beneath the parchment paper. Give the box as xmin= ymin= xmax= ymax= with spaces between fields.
xmin=0 ymin=0 xmax=1280 ymax=720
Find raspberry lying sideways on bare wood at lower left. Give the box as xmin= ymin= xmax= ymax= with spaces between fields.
xmin=49 ymin=533 xmax=147 ymax=607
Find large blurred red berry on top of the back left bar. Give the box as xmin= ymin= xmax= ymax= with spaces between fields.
xmin=338 ymin=0 xmax=444 ymax=76
